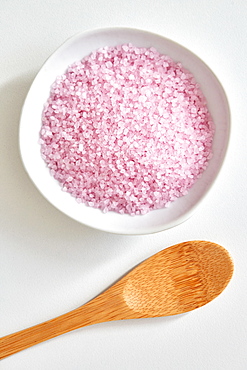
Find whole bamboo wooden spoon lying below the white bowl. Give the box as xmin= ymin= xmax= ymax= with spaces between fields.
xmin=0 ymin=241 xmax=233 ymax=359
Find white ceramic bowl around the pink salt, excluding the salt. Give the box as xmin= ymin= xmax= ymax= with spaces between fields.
xmin=20 ymin=28 xmax=230 ymax=234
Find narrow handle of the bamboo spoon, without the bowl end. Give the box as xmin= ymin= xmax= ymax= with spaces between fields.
xmin=0 ymin=290 xmax=126 ymax=359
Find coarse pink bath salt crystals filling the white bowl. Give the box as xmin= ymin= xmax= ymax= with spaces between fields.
xmin=40 ymin=44 xmax=214 ymax=215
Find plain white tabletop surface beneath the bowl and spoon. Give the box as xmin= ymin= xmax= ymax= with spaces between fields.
xmin=0 ymin=0 xmax=247 ymax=370
